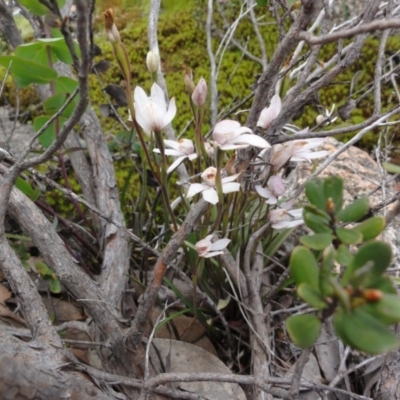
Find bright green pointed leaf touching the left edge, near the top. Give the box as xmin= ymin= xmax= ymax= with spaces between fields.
xmin=0 ymin=56 xmax=57 ymax=87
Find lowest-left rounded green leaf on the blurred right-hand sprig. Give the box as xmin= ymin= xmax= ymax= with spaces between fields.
xmin=286 ymin=315 xmax=321 ymax=349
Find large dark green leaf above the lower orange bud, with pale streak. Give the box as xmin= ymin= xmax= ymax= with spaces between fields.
xmin=342 ymin=241 xmax=392 ymax=287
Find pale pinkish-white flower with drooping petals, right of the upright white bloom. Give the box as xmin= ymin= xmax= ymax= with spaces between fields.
xmin=213 ymin=119 xmax=271 ymax=150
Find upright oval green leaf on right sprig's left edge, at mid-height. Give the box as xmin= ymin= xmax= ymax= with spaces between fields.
xmin=289 ymin=246 xmax=319 ymax=290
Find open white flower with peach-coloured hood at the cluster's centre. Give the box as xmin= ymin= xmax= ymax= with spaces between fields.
xmin=186 ymin=167 xmax=240 ymax=204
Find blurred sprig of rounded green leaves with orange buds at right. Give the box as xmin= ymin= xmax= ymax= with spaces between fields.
xmin=286 ymin=177 xmax=400 ymax=354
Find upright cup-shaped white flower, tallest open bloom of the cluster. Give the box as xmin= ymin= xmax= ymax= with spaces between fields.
xmin=133 ymin=83 xmax=176 ymax=135
